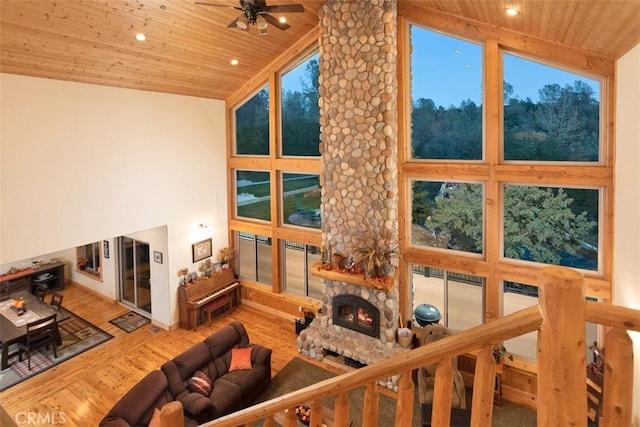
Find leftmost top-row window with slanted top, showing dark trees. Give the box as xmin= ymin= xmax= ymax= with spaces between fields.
xmin=235 ymin=87 xmax=269 ymax=156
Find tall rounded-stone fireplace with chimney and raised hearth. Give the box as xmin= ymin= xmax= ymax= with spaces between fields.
xmin=298 ymin=0 xmax=407 ymax=388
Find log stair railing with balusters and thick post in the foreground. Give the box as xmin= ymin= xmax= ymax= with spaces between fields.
xmin=204 ymin=267 xmax=640 ymax=427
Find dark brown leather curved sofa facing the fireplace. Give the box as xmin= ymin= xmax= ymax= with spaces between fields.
xmin=100 ymin=321 xmax=271 ymax=427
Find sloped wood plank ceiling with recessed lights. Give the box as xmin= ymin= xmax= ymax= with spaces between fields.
xmin=0 ymin=0 xmax=640 ymax=99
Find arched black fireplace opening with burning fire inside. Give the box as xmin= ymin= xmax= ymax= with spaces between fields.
xmin=333 ymin=294 xmax=380 ymax=338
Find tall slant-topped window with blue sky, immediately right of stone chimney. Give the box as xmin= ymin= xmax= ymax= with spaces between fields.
xmin=411 ymin=26 xmax=482 ymax=160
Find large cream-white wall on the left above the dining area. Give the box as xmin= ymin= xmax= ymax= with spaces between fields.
xmin=0 ymin=74 xmax=228 ymax=325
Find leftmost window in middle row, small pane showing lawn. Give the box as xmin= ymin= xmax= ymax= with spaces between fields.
xmin=236 ymin=170 xmax=271 ymax=221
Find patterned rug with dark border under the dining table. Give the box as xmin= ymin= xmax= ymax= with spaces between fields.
xmin=0 ymin=310 xmax=113 ymax=391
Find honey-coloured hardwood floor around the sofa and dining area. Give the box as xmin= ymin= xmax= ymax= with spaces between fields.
xmin=0 ymin=284 xmax=341 ymax=427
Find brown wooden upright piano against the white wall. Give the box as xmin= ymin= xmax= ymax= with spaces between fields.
xmin=178 ymin=269 xmax=240 ymax=330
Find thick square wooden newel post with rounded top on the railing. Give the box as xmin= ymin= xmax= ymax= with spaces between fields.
xmin=538 ymin=267 xmax=587 ymax=426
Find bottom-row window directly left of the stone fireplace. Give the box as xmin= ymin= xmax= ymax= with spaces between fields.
xmin=282 ymin=240 xmax=324 ymax=300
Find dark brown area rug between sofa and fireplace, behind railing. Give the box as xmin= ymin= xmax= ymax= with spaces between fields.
xmin=257 ymin=357 xmax=537 ymax=427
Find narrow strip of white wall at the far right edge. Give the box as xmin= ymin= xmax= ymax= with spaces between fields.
xmin=613 ymin=44 xmax=640 ymax=424
